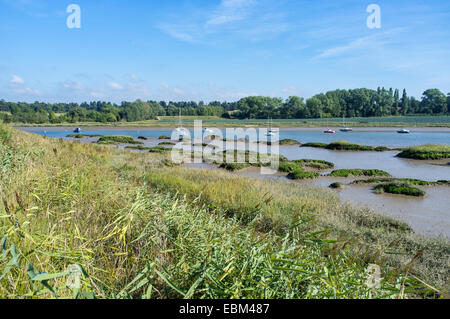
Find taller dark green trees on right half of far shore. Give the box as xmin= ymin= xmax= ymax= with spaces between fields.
xmin=234 ymin=88 xmax=450 ymax=119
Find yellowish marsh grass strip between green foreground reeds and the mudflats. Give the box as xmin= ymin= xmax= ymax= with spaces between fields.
xmin=147 ymin=169 xmax=449 ymax=296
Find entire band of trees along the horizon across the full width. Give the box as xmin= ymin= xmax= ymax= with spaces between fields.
xmin=0 ymin=88 xmax=450 ymax=124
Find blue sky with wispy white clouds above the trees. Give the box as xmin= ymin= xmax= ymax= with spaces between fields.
xmin=0 ymin=0 xmax=450 ymax=102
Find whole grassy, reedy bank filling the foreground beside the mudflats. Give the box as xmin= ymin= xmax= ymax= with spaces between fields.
xmin=0 ymin=125 xmax=449 ymax=298
